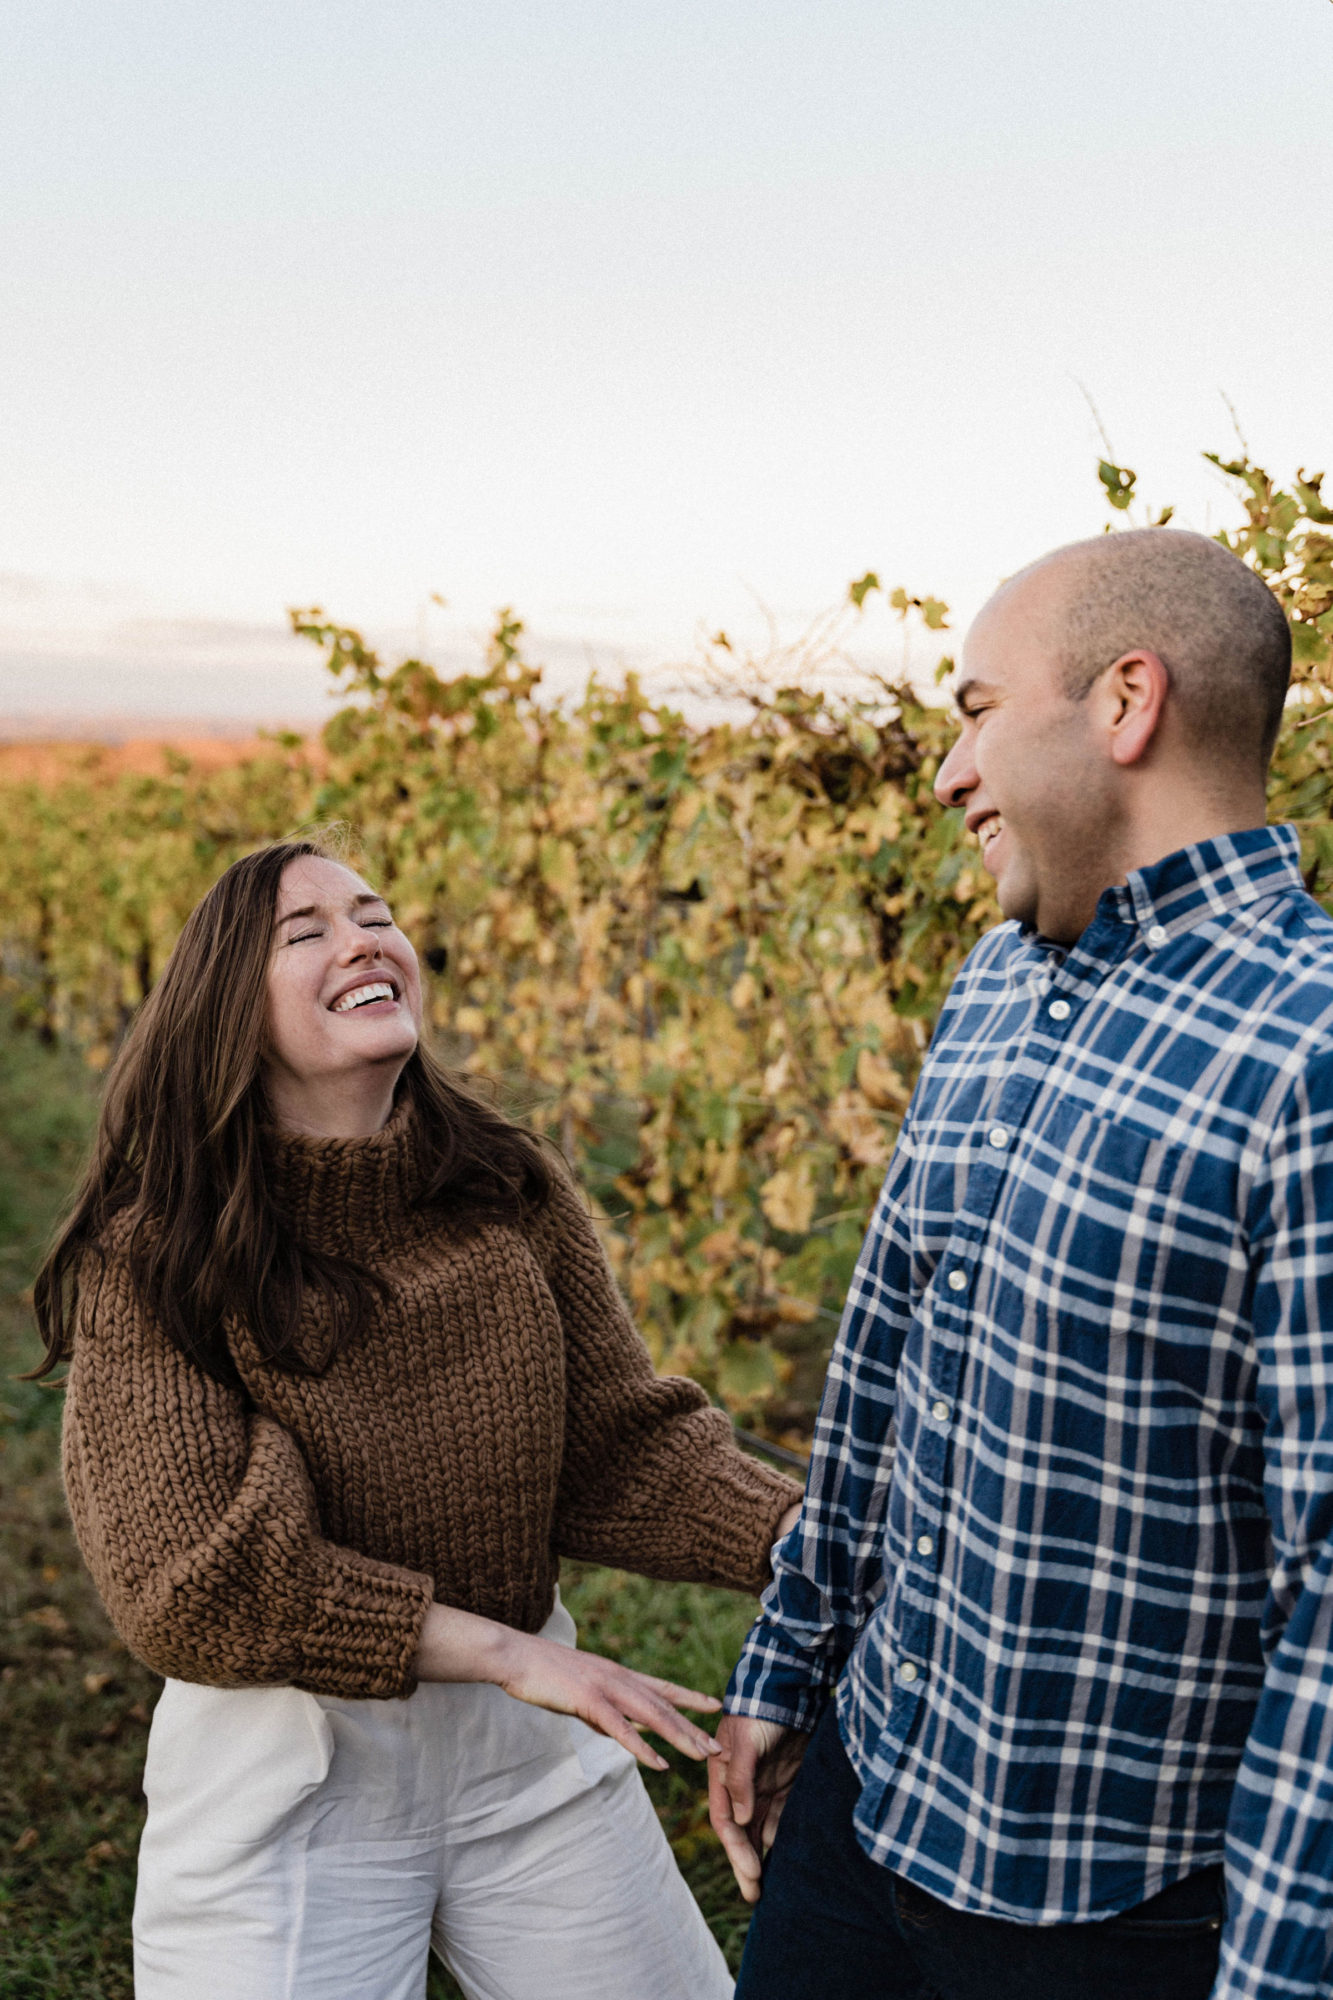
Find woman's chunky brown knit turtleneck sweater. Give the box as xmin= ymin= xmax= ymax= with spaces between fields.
xmin=64 ymin=1108 xmax=799 ymax=1698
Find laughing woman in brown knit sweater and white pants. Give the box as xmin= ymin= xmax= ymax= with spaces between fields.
xmin=36 ymin=840 xmax=797 ymax=2000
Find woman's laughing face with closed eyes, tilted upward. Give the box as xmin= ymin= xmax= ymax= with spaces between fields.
xmin=264 ymin=854 xmax=420 ymax=1130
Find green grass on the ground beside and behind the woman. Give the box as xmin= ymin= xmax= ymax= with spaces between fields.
xmin=0 ymin=1018 xmax=753 ymax=2000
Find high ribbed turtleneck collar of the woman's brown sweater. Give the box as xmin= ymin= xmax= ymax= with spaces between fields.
xmin=264 ymin=1098 xmax=422 ymax=1258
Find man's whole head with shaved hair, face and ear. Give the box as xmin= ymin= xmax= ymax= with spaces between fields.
xmin=935 ymin=528 xmax=1291 ymax=944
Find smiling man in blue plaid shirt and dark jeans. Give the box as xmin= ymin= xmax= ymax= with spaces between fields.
xmin=711 ymin=530 xmax=1333 ymax=2000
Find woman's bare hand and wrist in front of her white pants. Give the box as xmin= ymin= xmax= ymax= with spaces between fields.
xmin=416 ymin=1604 xmax=723 ymax=1770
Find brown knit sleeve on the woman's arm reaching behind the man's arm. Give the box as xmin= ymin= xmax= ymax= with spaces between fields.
xmin=534 ymin=1178 xmax=801 ymax=1592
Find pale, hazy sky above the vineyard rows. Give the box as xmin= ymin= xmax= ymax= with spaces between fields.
xmin=0 ymin=0 xmax=1333 ymax=734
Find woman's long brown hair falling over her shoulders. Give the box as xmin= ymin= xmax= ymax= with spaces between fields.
xmin=34 ymin=840 xmax=552 ymax=1382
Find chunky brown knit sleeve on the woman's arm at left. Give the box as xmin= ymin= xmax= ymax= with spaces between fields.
xmin=64 ymin=1250 xmax=434 ymax=1698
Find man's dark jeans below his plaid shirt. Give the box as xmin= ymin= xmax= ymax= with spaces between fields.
xmin=737 ymin=1708 xmax=1223 ymax=2000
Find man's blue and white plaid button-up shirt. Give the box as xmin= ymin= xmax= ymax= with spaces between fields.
xmin=727 ymin=826 xmax=1333 ymax=2000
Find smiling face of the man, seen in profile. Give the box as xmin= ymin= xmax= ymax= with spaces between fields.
xmin=935 ymin=570 xmax=1119 ymax=944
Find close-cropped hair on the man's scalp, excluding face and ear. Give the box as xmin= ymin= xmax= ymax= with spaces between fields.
xmin=999 ymin=528 xmax=1291 ymax=770
